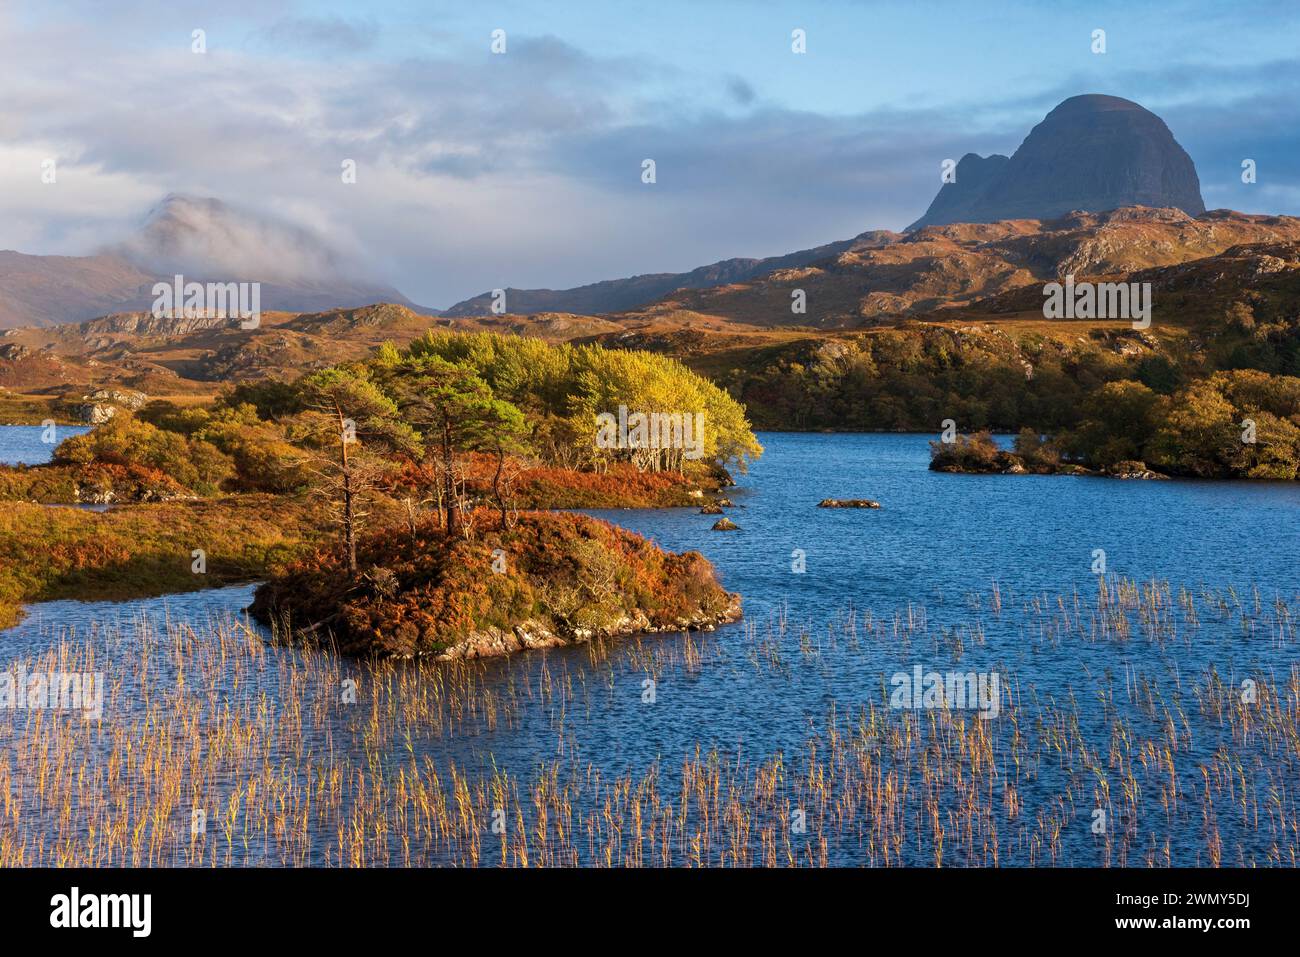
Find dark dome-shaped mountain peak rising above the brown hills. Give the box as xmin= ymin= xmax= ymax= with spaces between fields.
xmin=907 ymin=94 xmax=1205 ymax=230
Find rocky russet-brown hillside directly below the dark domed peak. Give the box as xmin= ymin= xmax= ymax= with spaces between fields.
xmin=615 ymin=207 xmax=1300 ymax=329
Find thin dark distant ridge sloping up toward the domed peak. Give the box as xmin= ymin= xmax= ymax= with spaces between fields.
xmin=442 ymin=233 xmax=879 ymax=316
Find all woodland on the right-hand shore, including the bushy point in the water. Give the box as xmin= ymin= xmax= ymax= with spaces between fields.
xmin=719 ymin=315 xmax=1300 ymax=479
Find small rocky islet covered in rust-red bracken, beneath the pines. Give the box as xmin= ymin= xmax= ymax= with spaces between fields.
xmin=251 ymin=512 xmax=741 ymax=659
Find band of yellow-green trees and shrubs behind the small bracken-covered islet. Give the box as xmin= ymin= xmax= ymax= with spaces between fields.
xmin=40 ymin=333 xmax=762 ymax=570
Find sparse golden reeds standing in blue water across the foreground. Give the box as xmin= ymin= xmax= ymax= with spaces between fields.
xmin=0 ymin=579 xmax=1300 ymax=867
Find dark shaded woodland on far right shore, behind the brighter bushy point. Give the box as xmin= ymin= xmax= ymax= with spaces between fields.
xmin=711 ymin=315 xmax=1300 ymax=433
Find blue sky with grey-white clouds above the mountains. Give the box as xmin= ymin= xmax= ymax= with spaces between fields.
xmin=0 ymin=0 xmax=1300 ymax=307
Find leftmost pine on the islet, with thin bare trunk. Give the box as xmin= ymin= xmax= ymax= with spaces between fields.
xmin=299 ymin=365 xmax=420 ymax=577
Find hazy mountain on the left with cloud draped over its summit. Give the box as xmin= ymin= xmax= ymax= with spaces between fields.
xmin=0 ymin=194 xmax=436 ymax=329
